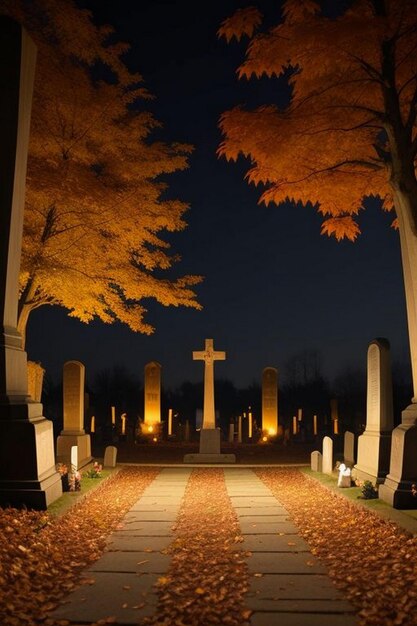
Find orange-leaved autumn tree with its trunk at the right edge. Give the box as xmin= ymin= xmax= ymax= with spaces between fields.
xmin=219 ymin=0 xmax=417 ymax=407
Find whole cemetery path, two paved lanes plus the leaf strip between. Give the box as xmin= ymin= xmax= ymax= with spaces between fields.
xmin=51 ymin=467 xmax=357 ymax=626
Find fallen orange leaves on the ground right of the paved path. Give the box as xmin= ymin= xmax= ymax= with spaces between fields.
xmin=256 ymin=468 xmax=417 ymax=626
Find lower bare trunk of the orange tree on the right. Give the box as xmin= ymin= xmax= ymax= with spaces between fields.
xmin=394 ymin=189 xmax=417 ymax=404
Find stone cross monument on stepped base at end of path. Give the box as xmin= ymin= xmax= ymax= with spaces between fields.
xmin=184 ymin=339 xmax=236 ymax=463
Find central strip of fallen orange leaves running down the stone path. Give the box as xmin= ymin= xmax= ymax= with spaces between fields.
xmin=148 ymin=468 xmax=250 ymax=626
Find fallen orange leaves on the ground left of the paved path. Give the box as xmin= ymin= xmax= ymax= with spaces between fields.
xmin=0 ymin=468 xmax=159 ymax=626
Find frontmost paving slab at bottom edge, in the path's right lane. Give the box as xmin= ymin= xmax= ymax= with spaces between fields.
xmin=250 ymin=612 xmax=358 ymax=626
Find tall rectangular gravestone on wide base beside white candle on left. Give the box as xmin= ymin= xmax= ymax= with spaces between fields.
xmin=57 ymin=361 xmax=92 ymax=468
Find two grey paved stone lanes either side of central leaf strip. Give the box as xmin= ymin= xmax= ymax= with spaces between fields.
xmin=51 ymin=466 xmax=357 ymax=626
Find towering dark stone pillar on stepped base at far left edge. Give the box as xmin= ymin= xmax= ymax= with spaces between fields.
xmin=0 ymin=16 xmax=62 ymax=509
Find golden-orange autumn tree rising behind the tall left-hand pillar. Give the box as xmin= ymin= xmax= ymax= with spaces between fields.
xmin=0 ymin=0 xmax=200 ymax=344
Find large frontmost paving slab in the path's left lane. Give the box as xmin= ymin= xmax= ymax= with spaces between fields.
xmin=51 ymin=572 xmax=158 ymax=624
